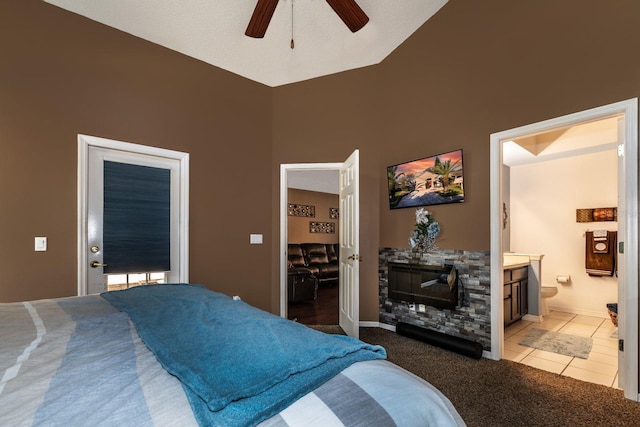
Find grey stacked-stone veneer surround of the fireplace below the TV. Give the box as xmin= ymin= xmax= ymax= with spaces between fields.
xmin=378 ymin=248 xmax=491 ymax=352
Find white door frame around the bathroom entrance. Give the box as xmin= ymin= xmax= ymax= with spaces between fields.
xmin=490 ymin=98 xmax=640 ymax=401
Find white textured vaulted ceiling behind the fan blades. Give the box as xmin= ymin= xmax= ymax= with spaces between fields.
xmin=45 ymin=0 xmax=448 ymax=86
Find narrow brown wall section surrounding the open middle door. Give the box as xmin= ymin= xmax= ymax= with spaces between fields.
xmin=272 ymin=67 xmax=380 ymax=321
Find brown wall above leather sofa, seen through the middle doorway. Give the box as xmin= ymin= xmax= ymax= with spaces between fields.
xmin=287 ymin=188 xmax=340 ymax=243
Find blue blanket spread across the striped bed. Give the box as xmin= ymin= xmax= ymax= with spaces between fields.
xmin=102 ymin=285 xmax=386 ymax=426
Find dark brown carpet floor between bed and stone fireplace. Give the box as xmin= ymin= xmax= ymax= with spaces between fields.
xmin=316 ymin=326 xmax=640 ymax=427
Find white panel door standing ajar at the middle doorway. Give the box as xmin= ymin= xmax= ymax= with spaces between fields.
xmin=339 ymin=150 xmax=361 ymax=338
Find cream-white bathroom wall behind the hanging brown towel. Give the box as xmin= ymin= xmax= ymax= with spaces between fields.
xmin=509 ymin=150 xmax=618 ymax=317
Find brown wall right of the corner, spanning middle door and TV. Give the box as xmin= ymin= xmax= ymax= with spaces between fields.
xmin=273 ymin=0 xmax=640 ymax=321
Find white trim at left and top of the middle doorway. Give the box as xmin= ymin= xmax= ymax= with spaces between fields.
xmin=280 ymin=163 xmax=343 ymax=319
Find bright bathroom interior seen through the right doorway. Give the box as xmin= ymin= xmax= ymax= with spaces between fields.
xmin=502 ymin=117 xmax=619 ymax=387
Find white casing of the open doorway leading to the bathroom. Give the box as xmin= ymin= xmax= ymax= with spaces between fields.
xmin=491 ymin=99 xmax=638 ymax=401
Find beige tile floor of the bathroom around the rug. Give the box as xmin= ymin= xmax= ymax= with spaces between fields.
xmin=504 ymin=311 xmax=618 ymax=388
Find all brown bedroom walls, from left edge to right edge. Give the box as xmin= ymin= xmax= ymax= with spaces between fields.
xmin=0 ymin=0 xmax=640 ymax=321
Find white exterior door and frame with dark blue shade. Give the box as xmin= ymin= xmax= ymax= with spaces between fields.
xmin=78 ymin=135 xmax=188 ymax=295
